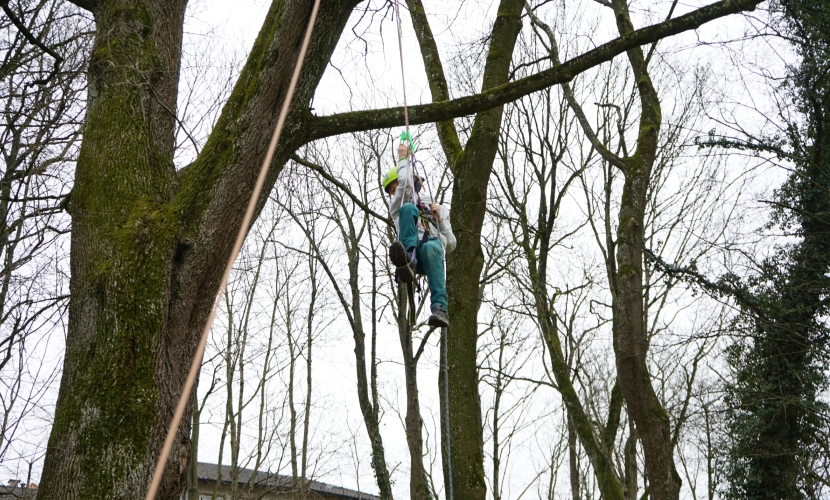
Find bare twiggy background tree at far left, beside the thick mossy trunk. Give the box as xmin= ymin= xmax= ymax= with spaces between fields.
xmin=0 ymin=0 xmax=91 ymax=479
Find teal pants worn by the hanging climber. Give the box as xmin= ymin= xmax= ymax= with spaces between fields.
xmin=398 ymin=203 xmax=447 ymax=311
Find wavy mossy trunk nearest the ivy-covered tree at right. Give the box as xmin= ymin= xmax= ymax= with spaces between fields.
xmin=611 ymin=0 xmax=681 ymax=500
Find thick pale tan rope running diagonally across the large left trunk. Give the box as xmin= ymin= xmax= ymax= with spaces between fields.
xmin=145 ymin=0 xmax=320 ymax=500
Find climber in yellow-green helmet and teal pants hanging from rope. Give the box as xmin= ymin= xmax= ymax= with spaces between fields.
xmin=383 ymin=142 xmax=455 ymax=328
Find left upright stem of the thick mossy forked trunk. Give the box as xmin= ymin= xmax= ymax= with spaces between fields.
xmin=38 ymin=0 xmax=189 ymax=499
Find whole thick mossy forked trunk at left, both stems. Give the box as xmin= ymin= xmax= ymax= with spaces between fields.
xmin=38 ymin=0 xmax=358 ymax=499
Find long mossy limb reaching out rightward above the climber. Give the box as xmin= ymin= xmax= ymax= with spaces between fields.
xmin=307 ymin=0 xmax=761 ymax=142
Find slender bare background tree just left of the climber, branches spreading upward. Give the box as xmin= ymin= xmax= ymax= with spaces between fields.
xmin=278 ymin=139 xmax=400 ymax=498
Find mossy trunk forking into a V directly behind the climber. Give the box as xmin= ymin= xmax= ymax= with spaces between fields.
xmin=407 ymin=0 xmax=524 ymax=500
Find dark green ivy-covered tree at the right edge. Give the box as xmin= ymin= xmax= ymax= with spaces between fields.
xmin=724 ymin=0 xmax=830 ymax=500
